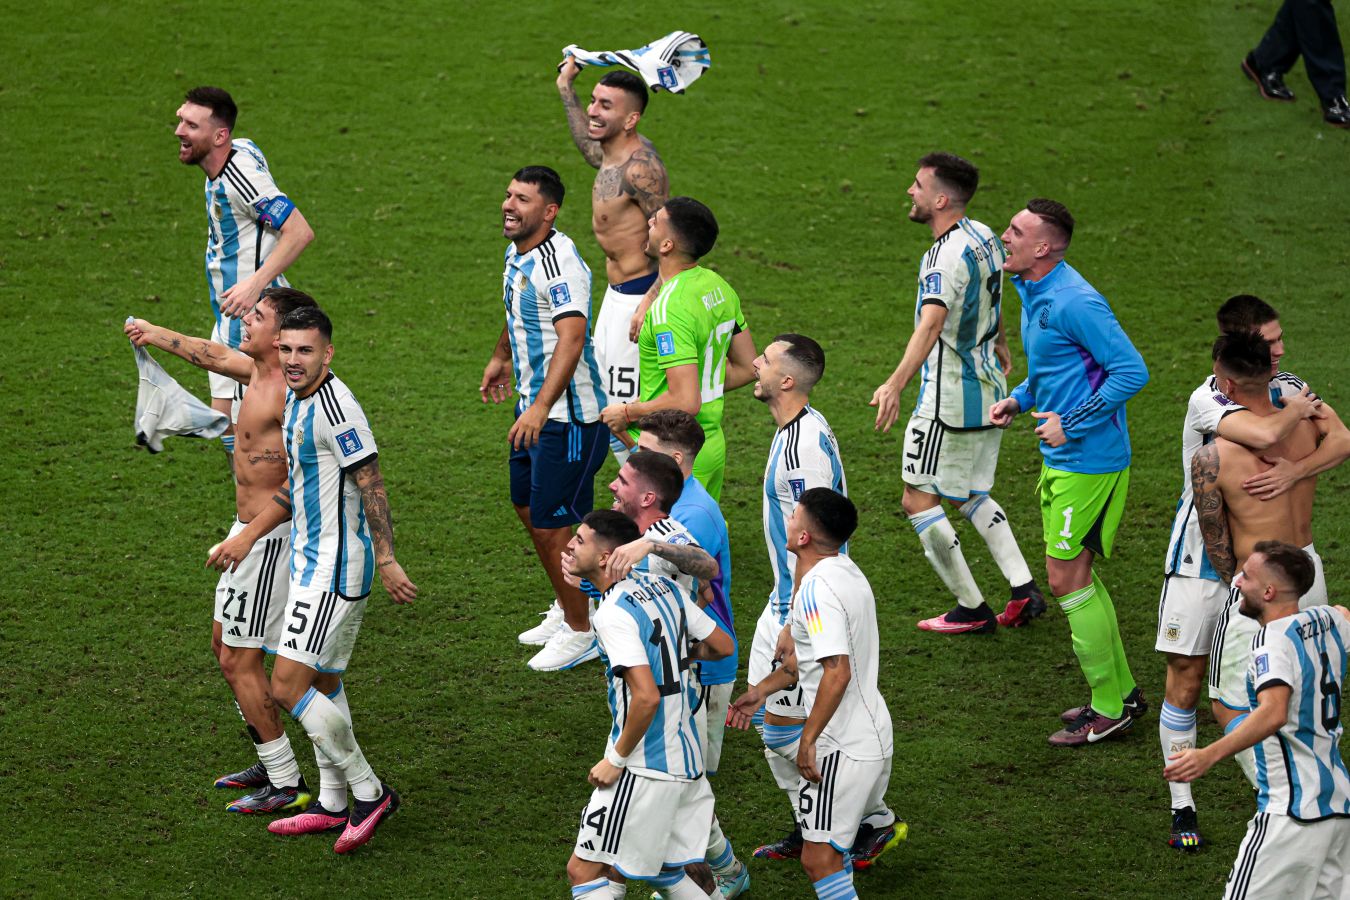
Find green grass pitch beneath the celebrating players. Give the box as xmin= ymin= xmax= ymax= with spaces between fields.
xmin=0 ymin=0 xmax=1350 ymax=900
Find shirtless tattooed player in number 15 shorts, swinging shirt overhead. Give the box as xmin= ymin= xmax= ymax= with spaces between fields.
xmin=558 ymin=57 xmax=670 ymax=464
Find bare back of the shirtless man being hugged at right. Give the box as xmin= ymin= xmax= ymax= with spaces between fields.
xmin=1191 ymin=420 xmax=1319 ymax=582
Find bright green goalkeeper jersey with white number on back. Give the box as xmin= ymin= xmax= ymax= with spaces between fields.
xmin=637 ymin=266 xmax=745 ymax=434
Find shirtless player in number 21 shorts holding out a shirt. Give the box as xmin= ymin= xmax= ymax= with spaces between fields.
xmin=126 ymin=287 xmax=315 ymax=812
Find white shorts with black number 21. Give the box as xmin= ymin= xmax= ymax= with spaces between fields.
xmin=215 ymin=518 xmax=290 ymax=653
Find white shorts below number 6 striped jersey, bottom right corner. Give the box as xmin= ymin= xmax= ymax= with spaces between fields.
xmin=1223 ymin=812 xmax=1350 ymax=900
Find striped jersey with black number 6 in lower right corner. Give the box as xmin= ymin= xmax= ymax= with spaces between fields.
xmin=1247 ymin=606 xmax=1350 ymax=822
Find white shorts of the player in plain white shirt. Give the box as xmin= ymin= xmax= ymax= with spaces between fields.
xmin=797 ymin=750 xmax=895 ymax=853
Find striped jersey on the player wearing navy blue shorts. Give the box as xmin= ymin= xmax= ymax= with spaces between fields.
xmin=502 ymin=231 xmax=605 ymax=425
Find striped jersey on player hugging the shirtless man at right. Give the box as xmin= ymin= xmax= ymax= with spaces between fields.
xmin=1164 ymin=372 xmax=1303 ymax=582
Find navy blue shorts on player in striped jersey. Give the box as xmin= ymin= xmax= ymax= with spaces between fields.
xmin=510 ymin=420 xmax=609 ymax=528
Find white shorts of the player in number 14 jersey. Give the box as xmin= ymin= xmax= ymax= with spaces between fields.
xmin=572 ymin=769 xmax=713 ymax=880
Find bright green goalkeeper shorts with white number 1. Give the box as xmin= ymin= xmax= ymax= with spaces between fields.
xmin=1037 ymin=463 xmax=1130 ymax=560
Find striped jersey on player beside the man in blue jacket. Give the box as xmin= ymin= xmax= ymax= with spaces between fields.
xmin=914 ymin=217 xmax=1008 ymax=430
